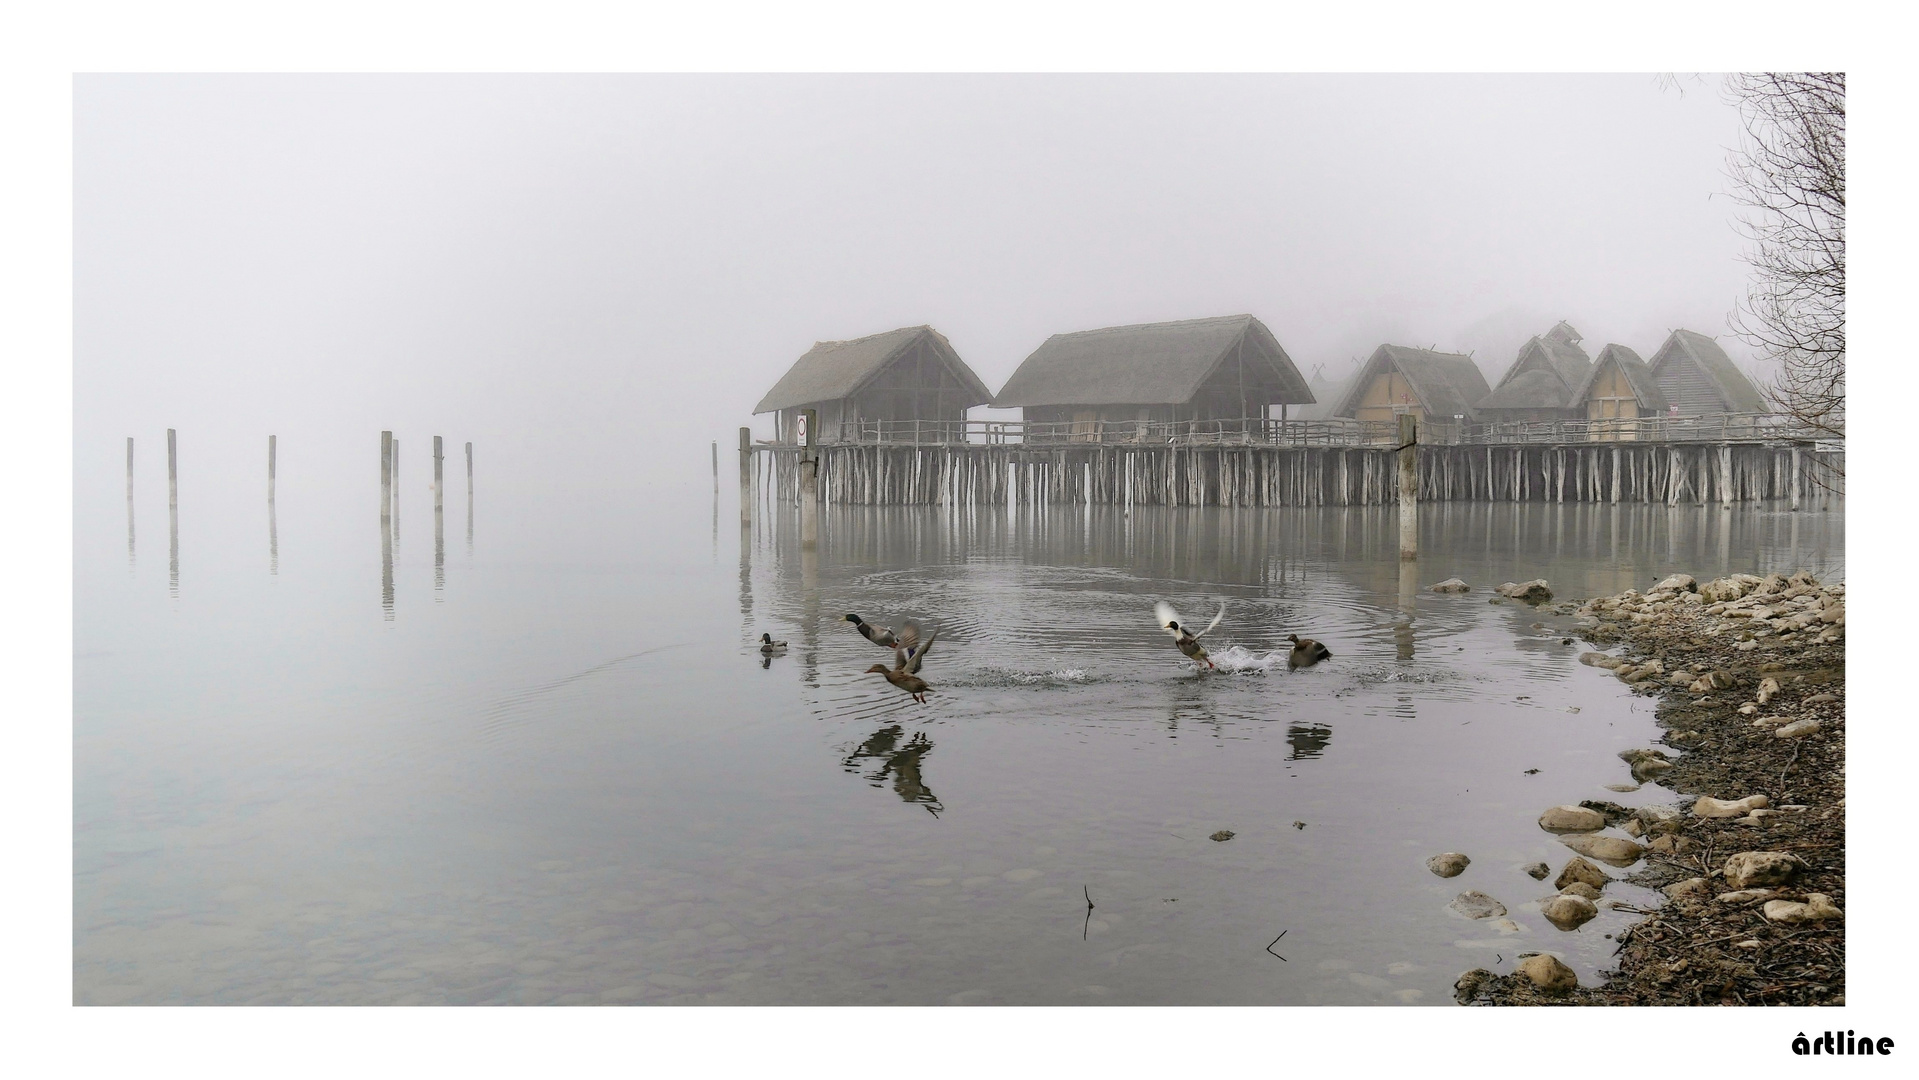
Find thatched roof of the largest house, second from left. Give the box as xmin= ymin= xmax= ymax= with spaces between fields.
xmin=992 ymin=315 xmax=1313 ymax=409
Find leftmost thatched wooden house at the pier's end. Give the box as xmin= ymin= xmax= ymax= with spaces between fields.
xmin=752 ymin=326 xmax=992 ymax=443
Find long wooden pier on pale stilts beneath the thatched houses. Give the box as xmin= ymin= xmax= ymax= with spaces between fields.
xmin=741 ymin=416 xmax=1844 ymax=510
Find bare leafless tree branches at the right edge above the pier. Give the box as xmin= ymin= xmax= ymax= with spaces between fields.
xmin=1725 ymin=71 xmax=1846 ymax=445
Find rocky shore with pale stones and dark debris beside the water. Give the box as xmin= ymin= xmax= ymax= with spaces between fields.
xmin=1435 ymin=572 xmax=1846 ymax=1005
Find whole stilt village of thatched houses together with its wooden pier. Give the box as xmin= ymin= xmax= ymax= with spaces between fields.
xmin=741 ymin=315 xmax=1842 ymax=506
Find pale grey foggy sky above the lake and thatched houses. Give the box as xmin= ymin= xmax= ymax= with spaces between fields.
xmin=75 ymin=75 xmax=1750 ymax=479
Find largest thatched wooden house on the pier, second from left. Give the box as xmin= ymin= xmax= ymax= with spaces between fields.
xmin=994 ymin=315 xmax=1313 ymax=441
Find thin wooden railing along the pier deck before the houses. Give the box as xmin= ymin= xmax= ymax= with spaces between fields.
xmin=823 ymin=412 xmax=1831 ymax=449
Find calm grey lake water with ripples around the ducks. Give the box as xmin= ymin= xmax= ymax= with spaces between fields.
xmin=73 ymin=474 xmax=1844 ymax=1005
